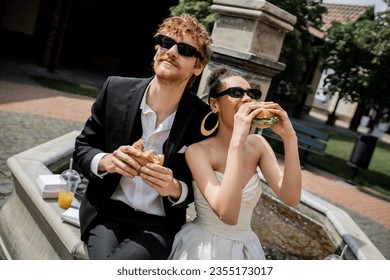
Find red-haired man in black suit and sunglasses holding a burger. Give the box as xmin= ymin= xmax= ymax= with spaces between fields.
xmin=74 ymin=15 xmax=212 ymax=259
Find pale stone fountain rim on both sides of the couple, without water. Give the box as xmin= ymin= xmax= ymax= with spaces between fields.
xmin=0 ymin=131 xmax=385 ymax=260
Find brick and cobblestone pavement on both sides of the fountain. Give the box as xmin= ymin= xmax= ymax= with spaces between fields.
xmin=0 ymin=53 xmax=390 ymax=259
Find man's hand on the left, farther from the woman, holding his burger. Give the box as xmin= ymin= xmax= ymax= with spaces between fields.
xmin=98 ymin=145 xmax=141 ymax=178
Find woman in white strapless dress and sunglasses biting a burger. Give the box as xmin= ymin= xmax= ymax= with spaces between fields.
xmin=169 ymin=66 xmax=301 ymax=259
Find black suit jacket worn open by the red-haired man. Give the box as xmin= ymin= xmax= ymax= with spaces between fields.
xmin=73 ymin=77 xmax=210 ymax=241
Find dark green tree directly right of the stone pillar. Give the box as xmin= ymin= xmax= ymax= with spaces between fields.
xmin=268 ymin=0 xmax=326 ymax=102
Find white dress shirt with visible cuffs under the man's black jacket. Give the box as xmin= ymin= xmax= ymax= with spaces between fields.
xmin=90 ymin=89 xmax=188 ymax=216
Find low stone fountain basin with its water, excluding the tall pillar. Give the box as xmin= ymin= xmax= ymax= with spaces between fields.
xmin=0 ymin=131 xmax=385 ymax=260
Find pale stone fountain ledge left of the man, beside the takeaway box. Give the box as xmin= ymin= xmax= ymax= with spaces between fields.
xmin=0 ymin=131 xmax=88 ymax=259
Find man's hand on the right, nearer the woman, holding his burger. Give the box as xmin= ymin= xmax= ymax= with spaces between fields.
xmin=140 ymin=163 xmax=181 ymax=200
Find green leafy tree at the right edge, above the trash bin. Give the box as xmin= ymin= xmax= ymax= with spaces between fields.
xmin=323 ymin=9 xmax=390 ymax=129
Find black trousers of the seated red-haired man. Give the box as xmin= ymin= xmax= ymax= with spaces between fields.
xmin=87 ymin=200 xmax=175 ymax=260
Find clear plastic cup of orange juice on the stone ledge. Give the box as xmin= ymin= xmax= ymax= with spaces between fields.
xmin=58 ymin=169 xmax=81 ymax=209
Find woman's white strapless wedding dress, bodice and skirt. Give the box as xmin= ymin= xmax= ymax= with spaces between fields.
xmin=168 ymin=171 xmax=265 ymax=260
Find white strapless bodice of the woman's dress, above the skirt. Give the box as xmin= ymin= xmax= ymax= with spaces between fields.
xmin=193 ymin=171 xmax=262 ymax=240
